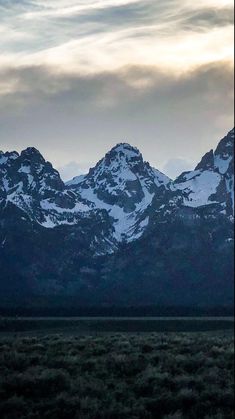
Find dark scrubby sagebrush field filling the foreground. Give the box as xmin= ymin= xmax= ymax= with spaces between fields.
xmin=0 ymin=328 xmax=234 ymax=419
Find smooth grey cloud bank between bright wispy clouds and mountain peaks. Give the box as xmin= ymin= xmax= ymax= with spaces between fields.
xmin=0 ymin=63 xmax=233 ymax=175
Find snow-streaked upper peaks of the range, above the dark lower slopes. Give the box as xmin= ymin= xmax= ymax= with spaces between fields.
xmin=0 ymin=129 xmax=234 ymax=247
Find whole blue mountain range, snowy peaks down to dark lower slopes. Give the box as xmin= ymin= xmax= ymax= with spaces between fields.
xmin=0 ymin=130 xmax=234 ymax=312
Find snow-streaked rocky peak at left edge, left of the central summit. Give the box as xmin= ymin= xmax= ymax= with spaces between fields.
xmin=0 ymin=148 xmax=88 ymax=227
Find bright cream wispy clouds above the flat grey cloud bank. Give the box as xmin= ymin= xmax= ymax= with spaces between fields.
xmin=0 ymin=0 xmax=233 ymax=77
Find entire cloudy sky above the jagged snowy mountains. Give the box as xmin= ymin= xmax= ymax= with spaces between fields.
xmin=0 ymin=0 xmax=233 ymax=179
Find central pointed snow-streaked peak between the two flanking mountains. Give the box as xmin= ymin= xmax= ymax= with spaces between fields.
xmin=67 ymin=143 xmax=171 ymax=242
